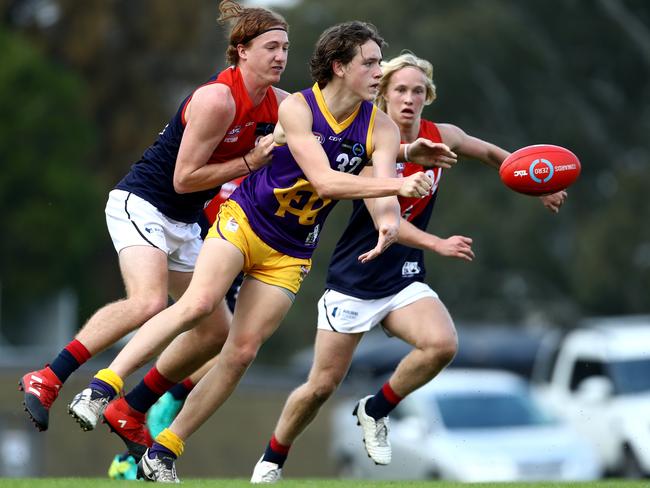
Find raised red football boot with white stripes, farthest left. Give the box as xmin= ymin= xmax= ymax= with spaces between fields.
xmin=18 ymin=366 xmax=63 ymax=431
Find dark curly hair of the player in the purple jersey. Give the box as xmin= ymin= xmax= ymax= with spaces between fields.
xmin=309 ymin=20 xmax=387 ymax=88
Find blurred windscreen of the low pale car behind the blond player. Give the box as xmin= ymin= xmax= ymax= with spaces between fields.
xmin=436 ymin=393 xmax=552 ymax=429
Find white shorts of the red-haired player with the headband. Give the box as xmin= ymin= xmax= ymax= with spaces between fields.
xmin=106 ymin=190 xmax=203 ymax=272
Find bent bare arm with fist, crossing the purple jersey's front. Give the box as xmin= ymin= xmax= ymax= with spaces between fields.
xmin=278 ymin=94 xmax=431 ymax=200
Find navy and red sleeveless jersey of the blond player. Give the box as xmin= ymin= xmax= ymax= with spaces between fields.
xmin=325 ymin=120 xmax=442 ymax=300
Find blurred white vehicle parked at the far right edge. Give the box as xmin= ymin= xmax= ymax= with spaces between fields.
xmin=533 ymin=316 xmax=650 ymax=478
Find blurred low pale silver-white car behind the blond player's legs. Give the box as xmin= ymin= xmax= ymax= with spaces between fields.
xmin=331 ymin=369 xmax=602 ymax=482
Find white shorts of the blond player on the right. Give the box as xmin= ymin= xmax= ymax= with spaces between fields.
xmin=318 ymin=281 xmax=438 ymax=334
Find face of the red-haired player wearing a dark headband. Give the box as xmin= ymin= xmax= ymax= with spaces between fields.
xmin=240 ymin=30 xmax=289 ymax=84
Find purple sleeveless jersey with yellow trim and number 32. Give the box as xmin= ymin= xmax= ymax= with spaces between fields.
xmin=232 ymin=85 xmax=376 ymax=259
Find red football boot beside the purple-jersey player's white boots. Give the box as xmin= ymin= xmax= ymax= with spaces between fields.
xmin=104 ymin=397 xmax=153 ymax=463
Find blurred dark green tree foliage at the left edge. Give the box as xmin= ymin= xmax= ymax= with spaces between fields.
xmin=0 ymin=25 xmax=104 ymax=324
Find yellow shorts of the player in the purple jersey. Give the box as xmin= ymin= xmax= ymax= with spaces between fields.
xmin=205 ymin=200 xmax=311 ymax=294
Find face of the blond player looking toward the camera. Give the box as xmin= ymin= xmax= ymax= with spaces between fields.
xmin=385 ymin=66 xmax=427 ymax=126
